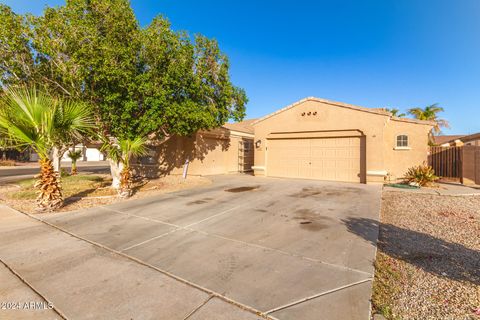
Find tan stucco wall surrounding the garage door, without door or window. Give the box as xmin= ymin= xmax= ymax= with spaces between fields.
xmin=254 ymin=99 xmax=432 ymax=182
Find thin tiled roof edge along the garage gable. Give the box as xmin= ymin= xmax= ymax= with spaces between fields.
xmin=253 ymin=97 xmax=435 ymax=125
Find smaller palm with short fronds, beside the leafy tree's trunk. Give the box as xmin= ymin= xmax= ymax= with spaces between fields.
xmin=102 ymin=136 xmax=147 ymax=198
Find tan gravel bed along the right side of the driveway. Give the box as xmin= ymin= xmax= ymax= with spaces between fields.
xmin=372 ymin=191 xmax=480 ymax=320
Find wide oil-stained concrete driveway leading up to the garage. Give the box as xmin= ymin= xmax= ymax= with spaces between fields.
xmin=0 ymin=175 xmax=381 ymax=320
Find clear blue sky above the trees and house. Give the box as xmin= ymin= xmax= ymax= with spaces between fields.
xmin=0 ymin=0 xmax=480 ymax=134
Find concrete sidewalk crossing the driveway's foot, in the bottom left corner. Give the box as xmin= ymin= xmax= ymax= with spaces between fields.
xmin=0 ymin=206 xmax=262 ymax=320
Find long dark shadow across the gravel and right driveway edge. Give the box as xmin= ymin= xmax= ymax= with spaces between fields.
xmin=342 ymin=218 xmax=480 ymax=285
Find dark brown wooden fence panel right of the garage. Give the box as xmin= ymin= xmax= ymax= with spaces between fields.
xmin=428 ymin=147 xmax=462 ymax=178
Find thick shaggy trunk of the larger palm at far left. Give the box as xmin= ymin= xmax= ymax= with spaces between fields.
xmin=35 ymin=158 xmax=63 ymax=211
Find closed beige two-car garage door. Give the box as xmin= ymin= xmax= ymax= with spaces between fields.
xmin=267 ymin=137 xmax=361 ymax=182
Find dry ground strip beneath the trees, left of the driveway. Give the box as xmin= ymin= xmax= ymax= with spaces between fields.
xmin=0 ymin=173 xmax=211 ymax=213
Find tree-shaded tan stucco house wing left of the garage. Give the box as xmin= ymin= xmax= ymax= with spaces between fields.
xmin=134 ymin=119 xmax=255 ymax=177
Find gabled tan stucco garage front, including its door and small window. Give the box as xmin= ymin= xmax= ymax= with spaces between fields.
xmin=249 ymin=98 xmax=434 ymax=183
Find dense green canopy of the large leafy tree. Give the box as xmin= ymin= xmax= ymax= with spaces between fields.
xmin=0 ymin=0 xmax=247 ymax=141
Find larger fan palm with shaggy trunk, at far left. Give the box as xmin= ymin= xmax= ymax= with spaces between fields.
xmin=0 ymin=88 xmax=94 ymax=211
